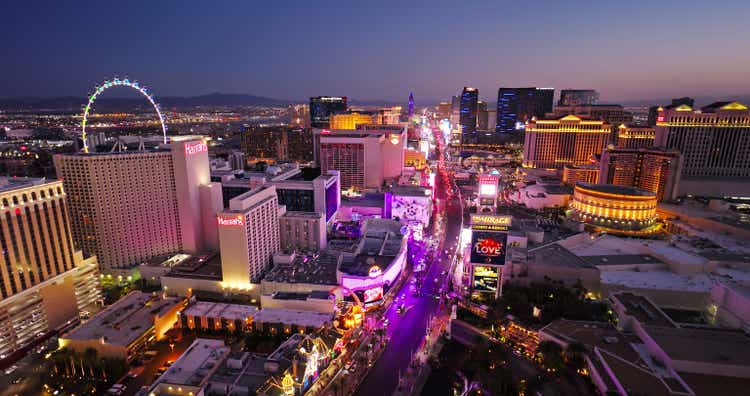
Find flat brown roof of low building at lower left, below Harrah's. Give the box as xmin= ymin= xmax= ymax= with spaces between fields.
xmin=62 ymin=291 xmax=184 ymax=346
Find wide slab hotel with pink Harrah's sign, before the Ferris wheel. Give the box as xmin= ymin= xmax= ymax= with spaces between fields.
xmin=55 ymin=136 xmax=222 ymax=271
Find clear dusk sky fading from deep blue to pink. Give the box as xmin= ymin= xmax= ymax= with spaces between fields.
xmin=0 ymin=0 xmax=750 ymax=103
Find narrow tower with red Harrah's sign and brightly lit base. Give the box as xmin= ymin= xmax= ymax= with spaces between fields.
xmin=222 ymin=185 xmax=285 ymax=289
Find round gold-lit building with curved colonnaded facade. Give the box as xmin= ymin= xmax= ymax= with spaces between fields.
xmin=570 ymin=183 xmax=658 ymax=234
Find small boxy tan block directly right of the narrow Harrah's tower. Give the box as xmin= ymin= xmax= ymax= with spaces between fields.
xmin=279 ymin=212 xmax=327 ymax=251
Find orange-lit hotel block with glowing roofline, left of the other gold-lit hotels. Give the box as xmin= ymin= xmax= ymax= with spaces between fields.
xmin=523 ymin=115 xmax=610 ymax=169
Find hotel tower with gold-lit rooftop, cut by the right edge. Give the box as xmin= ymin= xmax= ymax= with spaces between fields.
xmin=655 ymin=102 xmax=750 ymax=196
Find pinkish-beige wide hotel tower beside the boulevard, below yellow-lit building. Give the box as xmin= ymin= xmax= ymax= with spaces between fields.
xmin=314 ymin=126 xmax=407 ymax=190
